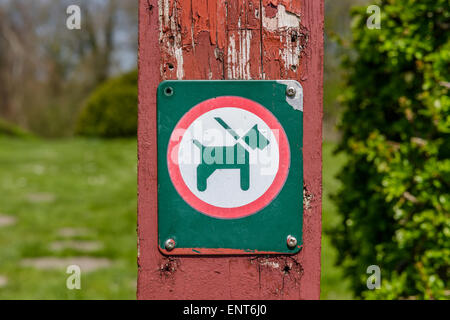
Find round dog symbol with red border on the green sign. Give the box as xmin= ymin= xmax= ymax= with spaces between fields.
xmin=167 ymin=96 xmax=290 ymax=219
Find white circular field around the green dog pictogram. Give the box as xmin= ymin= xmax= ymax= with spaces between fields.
xmin=175 ymin=107 xmax=280 ymax=208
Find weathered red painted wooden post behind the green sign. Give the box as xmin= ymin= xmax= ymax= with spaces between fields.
xmin=137 ymin=0 xmax=323 ymax=300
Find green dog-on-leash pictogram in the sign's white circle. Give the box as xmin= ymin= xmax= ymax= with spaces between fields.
xmin=193 ymin=117 xmax=270 ymax=192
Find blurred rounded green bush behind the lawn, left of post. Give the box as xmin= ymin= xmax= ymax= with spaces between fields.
xmin=75 ymin=71 xmax=138 ymax=138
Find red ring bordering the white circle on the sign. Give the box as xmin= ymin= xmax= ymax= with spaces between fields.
xmin=167 ymin=96 xmax=291 ymax=219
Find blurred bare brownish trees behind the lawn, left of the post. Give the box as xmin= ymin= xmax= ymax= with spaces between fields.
xmin=0 ymin=0 xmax=137 ymax=136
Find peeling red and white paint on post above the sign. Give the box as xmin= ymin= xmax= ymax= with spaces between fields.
xmin=158 ymin=0 xmax=305 ymax=80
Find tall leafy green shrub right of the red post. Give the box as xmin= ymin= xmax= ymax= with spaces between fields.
xmin=332 ymin=0 xmax=450 ymax=299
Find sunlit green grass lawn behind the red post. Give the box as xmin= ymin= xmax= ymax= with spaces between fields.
xmin=0 ymin=137 xmax=352 ymax=300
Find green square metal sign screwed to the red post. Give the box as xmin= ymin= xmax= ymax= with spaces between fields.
xmin=157 ymin=80 xmax=303 ymax=255
